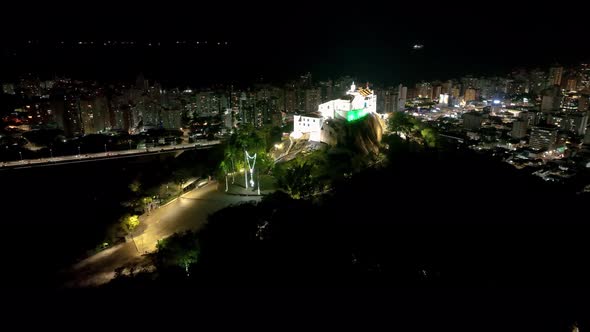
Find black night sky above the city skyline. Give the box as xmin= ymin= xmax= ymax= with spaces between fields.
xmin=2 ymin=2 xmax=590 ymax=85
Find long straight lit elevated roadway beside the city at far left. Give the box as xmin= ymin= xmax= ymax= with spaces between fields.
xmin=0 ymin=140 xmax=221 ymax=170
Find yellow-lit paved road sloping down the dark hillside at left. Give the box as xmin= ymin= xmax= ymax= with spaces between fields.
xmin=65 ymin=182 xmax=260 ymax=287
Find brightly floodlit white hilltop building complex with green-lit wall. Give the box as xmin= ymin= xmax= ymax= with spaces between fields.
xmin=291 ymin=82 xmax=377 ymax=142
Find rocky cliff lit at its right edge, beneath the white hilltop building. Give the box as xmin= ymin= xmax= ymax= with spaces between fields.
xmin=322 ymin=114 xmax=385 ymax=155
